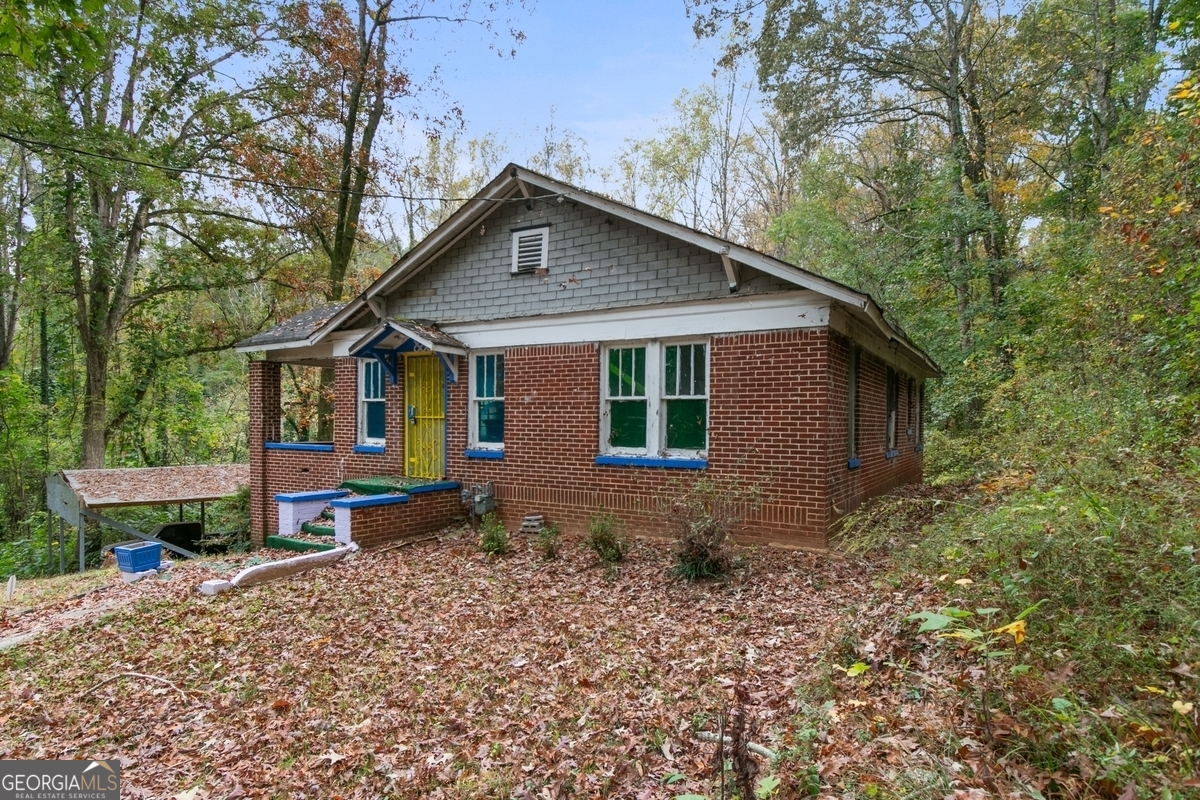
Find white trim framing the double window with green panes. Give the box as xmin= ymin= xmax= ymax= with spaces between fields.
xmin=600 ymin=338 xmax=713 ymax=458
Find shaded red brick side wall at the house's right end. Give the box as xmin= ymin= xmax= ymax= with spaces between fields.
xmin=828 ymin=332 xmax=922 ymax=523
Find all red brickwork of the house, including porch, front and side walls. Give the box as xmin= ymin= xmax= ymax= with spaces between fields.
xmin=251 ymin=329 xmax=920 ymax=547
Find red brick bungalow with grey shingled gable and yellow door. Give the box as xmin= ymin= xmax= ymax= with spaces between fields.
xmin=238 ymin=166 xmax=940 ymax=548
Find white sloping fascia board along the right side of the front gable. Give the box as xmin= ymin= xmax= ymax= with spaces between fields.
xmin=517 ymin=168 xmax=870 ymax=308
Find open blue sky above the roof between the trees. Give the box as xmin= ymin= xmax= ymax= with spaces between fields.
xmin=398 ymin=0 xmax=718 ymax=168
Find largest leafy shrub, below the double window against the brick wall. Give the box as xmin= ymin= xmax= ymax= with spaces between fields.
xmin=656 ymin=477 xmax=762 ymax=581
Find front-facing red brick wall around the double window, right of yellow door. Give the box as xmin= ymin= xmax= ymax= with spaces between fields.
xmin=448 ymin=330 xmax=827 ymax=547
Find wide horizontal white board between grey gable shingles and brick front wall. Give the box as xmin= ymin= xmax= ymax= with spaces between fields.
xmin=442 ymin=291 xmax=829 ymax=350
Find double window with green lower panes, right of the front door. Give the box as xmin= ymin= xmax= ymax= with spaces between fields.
xmin=601 ymin=342 xmax=708 ymax=456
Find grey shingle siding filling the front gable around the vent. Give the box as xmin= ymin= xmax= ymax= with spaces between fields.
xmin=386 ymin=194 xmax=796 ymax=321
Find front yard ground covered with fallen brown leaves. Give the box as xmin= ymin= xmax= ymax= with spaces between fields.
xmin=0 ymin=537 xmax=969 ymax=798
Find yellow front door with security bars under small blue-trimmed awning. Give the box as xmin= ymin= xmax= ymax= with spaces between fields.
xmin=404 ymin=353 xmax=446 ymax=477
